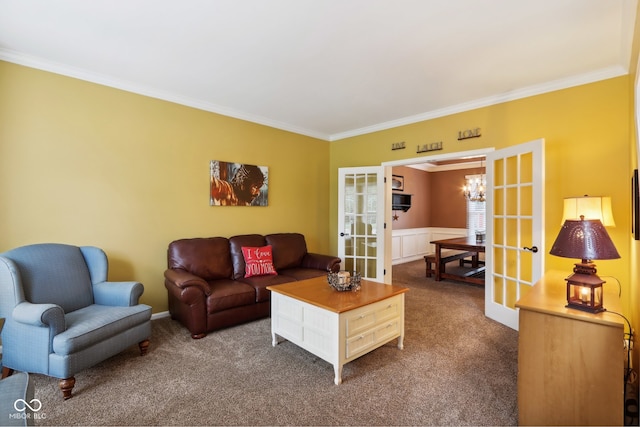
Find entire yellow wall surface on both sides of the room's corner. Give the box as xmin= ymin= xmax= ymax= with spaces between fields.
xmin=0 ymin=62 xmax=638 ymax=328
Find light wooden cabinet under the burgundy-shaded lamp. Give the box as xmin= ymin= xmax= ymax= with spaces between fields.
xmin=516 ymin=271 xmax=625 ymax=425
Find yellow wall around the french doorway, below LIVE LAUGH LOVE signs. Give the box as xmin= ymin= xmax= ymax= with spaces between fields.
xmin=330 ymin=76 xmax=631 ymax=318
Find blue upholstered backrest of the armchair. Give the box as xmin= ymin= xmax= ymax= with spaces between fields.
xmin=2 ymin=243 xmax=93 ymax=313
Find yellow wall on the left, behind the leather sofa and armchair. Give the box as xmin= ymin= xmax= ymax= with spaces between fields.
xmin=0 ymin=62 xmax=330 ymax=313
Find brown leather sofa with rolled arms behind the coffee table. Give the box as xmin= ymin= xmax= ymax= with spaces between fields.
xmin=164 ymin=233 xmax=340 ymax=339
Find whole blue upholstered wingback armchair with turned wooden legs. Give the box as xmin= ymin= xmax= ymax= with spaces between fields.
xmin=0 ymin=243 xmax=151 ymax=399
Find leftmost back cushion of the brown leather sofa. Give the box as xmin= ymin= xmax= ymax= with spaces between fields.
xmin=167 ymin=237 xmax=233 ymax=280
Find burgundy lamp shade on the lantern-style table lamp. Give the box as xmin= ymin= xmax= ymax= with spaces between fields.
xmin=549 ymin=219 xmax=620 ymax=262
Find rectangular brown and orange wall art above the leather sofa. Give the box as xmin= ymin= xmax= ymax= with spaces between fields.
xmin=209 ymin=160 xmax=269 ymax=206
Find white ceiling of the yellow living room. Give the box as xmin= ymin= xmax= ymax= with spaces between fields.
xmin=0 ymin=0 xmax=637 ymax=141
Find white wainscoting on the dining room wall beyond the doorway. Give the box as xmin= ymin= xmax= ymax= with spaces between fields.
xmin=391 ymin=227 xmax=467 ymax=264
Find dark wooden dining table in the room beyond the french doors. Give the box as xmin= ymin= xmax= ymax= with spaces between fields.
xmin=431 ymin=236 xmax=485 ymax=285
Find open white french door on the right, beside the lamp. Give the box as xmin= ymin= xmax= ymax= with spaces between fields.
xmin=485 ymin=139 xmax=545 ymax=330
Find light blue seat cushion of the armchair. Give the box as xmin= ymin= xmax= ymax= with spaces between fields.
xmin=53 ymin=304 xmax=151 ymax=355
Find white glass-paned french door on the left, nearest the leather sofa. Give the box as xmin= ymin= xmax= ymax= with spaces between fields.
xmin=338 ymin=166 xmax=391 ymax=282
